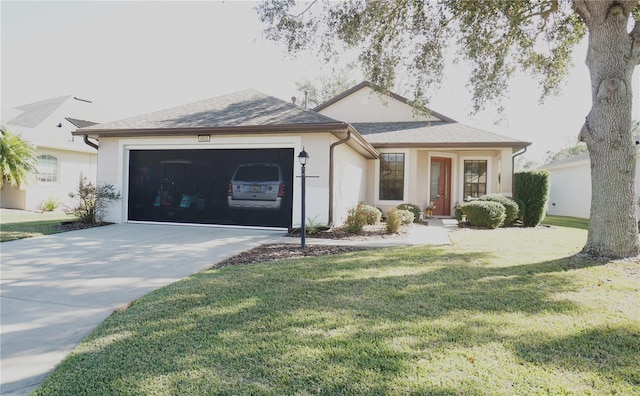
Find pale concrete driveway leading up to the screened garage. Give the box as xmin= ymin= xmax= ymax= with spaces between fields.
xmin=0 ymin=224 xmax=284 ymax=395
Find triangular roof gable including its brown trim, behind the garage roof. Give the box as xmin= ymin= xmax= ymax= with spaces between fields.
xmin=314 ymin=81 xmax=454 ymax=123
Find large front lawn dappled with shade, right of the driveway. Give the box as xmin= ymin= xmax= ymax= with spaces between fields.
xmin=34 ymin=227 xmax=640 ymax=395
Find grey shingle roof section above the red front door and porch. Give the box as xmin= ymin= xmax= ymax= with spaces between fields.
xmin=353 ymin=121 xmax=530 ymax=147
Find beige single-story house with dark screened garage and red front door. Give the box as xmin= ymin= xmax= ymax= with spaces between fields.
xmin=73 ymin=82 xmax=530 ymax=228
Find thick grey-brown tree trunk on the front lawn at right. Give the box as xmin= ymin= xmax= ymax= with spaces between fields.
xmin=575 ymin=1 xmax=640 ymax=257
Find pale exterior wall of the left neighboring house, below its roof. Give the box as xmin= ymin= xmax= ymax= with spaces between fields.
xmin=0 ymin=148 xmax=98 ymax=210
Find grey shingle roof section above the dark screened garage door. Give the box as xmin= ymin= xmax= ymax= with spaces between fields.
xmin=84 ymin=90 xmax=336 ymax=130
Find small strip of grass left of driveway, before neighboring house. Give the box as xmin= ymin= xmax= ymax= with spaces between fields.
xmin=0 ymin=210 xmax=74 ymax=242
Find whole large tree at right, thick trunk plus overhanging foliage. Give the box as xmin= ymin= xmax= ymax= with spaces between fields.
xmin=257 ymin=0 xmax=640 ymax=257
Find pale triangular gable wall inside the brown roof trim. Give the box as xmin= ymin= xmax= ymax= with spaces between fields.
xmin=320 ymin=87 xmax=436 ymax=123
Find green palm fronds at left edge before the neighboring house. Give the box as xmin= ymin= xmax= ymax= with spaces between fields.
xmin=0 ymin=126 xmax=36 ymax=187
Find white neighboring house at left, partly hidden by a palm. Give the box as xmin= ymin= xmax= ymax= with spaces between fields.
xmin=0 ymin=95 xmax=104 ymax=210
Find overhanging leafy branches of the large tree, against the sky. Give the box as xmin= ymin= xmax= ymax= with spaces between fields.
xmin=257 ymin=0 xmax=586 ymax=111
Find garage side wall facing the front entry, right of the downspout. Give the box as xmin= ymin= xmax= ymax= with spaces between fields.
xmin=333 ymin=139 xmax=371 ymax=225
